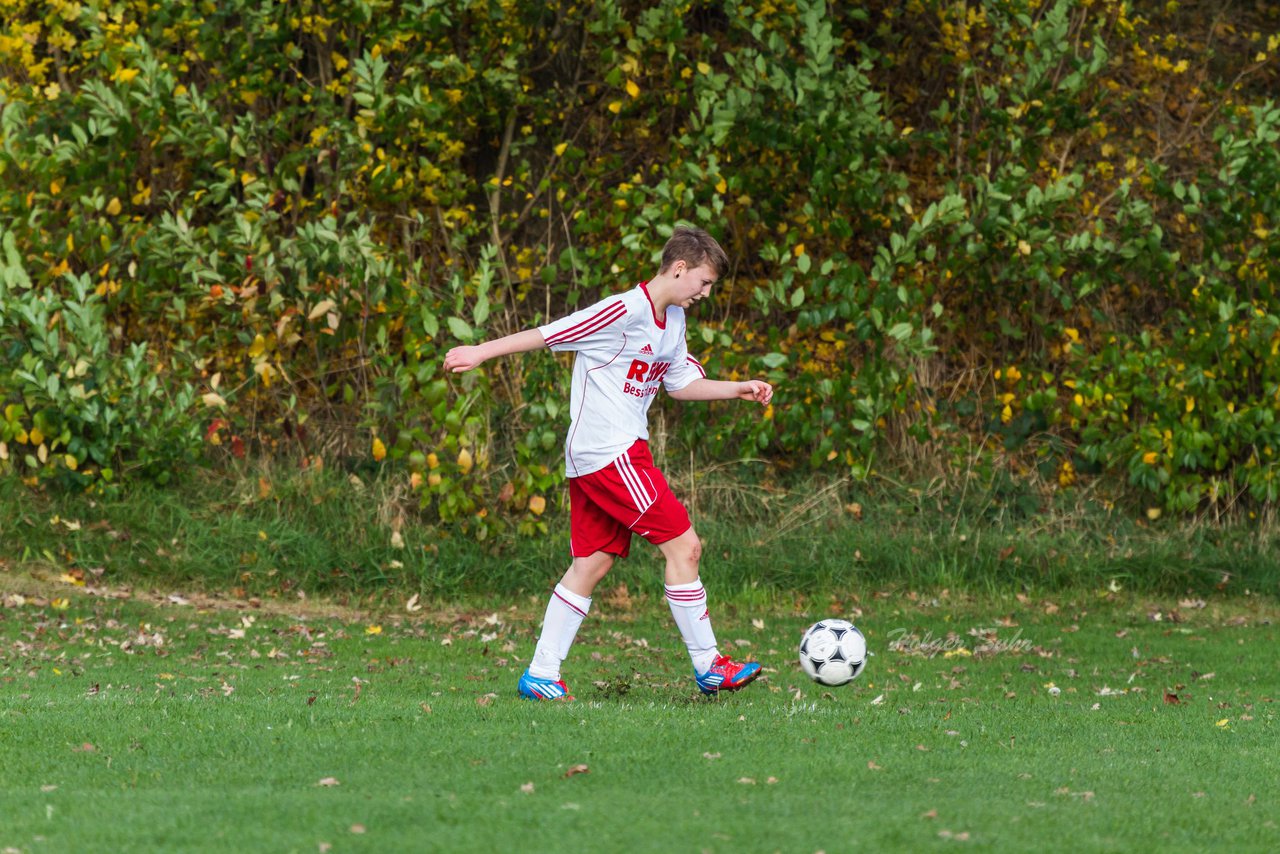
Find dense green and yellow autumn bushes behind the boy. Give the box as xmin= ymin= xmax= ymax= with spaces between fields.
xmin=0 ymin=0 xmax=1280 ymax=517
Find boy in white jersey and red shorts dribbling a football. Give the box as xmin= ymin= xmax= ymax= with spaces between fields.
xmin=444 ymin=227 xmax=773 ymax=700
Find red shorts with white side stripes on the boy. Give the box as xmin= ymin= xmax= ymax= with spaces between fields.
xmin=568 ymin=439 xmax=691 ymax=557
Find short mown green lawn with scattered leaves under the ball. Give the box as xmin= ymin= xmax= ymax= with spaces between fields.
xmin=0 ymin=572 xmax=1280 ymax=853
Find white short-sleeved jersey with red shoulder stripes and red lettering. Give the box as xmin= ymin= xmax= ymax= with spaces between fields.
xmin=538 ymin=283 xmax=707 ymax=478
